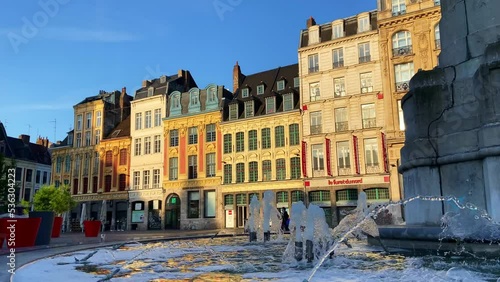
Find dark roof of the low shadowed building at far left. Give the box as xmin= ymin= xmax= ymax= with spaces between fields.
xmin=0 ymin=122 xmax=51 ymax=165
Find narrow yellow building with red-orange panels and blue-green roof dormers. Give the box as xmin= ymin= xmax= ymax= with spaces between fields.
xmin=163 ymin=84 xmax=231 ymax=229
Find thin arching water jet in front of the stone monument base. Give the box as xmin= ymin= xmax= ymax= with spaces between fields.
xmin=304 ymin=193 xmax=500 ymax=282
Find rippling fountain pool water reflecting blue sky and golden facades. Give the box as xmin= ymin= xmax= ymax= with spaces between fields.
xmin=13 ymin=237 xmax=500 ymax=282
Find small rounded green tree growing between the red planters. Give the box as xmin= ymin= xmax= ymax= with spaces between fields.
xmin=33 ymin=185 xmax=76 ymax=214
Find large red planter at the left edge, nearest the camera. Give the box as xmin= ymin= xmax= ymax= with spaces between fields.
xmin=0 ymin=217 xmax=42 ymax=248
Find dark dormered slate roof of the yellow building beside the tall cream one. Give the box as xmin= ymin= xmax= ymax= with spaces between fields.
xmin=223 ymin=64 xmax=300 ymax=121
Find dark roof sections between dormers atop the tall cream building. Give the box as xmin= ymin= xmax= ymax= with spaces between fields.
xmin=299 ymin=10 xmax=377 ymax=48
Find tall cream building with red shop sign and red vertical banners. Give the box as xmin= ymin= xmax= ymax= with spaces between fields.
xmin=298 ymin=11 xmax=390 ymax=226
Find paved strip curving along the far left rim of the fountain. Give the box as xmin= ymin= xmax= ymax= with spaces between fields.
xmin=0 ymin=229 xmax=243 ymax=282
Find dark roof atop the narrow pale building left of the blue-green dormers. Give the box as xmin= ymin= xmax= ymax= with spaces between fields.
xmin=135 ymin=71 xmax=198 ymax=100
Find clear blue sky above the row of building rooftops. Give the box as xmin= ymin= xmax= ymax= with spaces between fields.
xmin=0 ymin=0 xmax=376 ymax=141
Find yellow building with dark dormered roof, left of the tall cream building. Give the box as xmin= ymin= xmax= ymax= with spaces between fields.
xmin=221 ymin=63 xmax=304 ymax=228
